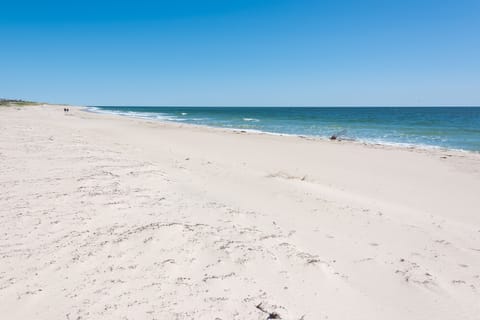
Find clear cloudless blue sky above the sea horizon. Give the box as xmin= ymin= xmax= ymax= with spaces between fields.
xmin=0 ymin=0 xmax=480 ymax=106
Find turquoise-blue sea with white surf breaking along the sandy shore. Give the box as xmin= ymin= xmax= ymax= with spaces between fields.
xmin=89 ymin=106 xmax=480 ymax=152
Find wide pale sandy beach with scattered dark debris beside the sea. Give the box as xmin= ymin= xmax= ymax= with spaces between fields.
xmin=0 ymin=106 xmax=480 ymax=320
